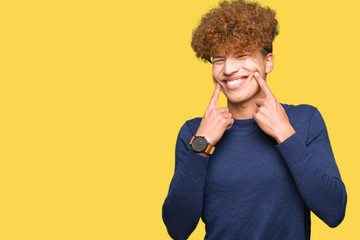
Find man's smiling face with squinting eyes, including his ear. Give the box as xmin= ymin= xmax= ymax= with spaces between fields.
xmin=212 ymin=50 xmax=274 ymax=103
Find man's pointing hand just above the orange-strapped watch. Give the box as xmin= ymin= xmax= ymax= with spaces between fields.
xmin=196 ymin=83 xmax=234 ymax=145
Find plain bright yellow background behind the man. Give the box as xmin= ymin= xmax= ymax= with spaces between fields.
xmin=0 ymin=0 xmax=360 ymax=240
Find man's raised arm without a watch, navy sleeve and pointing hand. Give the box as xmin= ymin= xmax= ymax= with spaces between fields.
xmin=253 ymin=73 xmax=347 ymax=227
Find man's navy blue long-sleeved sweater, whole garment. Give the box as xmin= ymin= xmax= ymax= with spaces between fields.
xmin=162 ymin=104 xmax=347 ymax=240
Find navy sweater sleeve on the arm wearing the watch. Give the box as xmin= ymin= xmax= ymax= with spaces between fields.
xmin=162 ymin=123 xmax=209 ymax=240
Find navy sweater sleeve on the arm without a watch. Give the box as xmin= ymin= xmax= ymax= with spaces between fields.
xmin=276 ymin=108 xmax=347 ymax=227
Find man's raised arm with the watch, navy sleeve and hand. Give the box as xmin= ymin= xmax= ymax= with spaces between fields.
xmin=163 ymin=84 xmax=234 ymax=240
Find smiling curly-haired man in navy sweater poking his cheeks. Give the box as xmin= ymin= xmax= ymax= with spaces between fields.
xmin=163 ymin=0 xmax=347 ymax=240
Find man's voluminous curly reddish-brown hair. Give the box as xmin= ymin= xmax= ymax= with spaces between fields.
xmin=191 ymin=0 xmax=279 ymax=63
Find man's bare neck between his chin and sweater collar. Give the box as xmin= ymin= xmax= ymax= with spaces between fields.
xmin=227 ymin=90 xmax=265 ymax=119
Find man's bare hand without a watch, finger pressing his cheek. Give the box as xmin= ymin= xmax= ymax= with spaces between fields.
xmin=252 ymin=72 xmax=295 ymax=143
